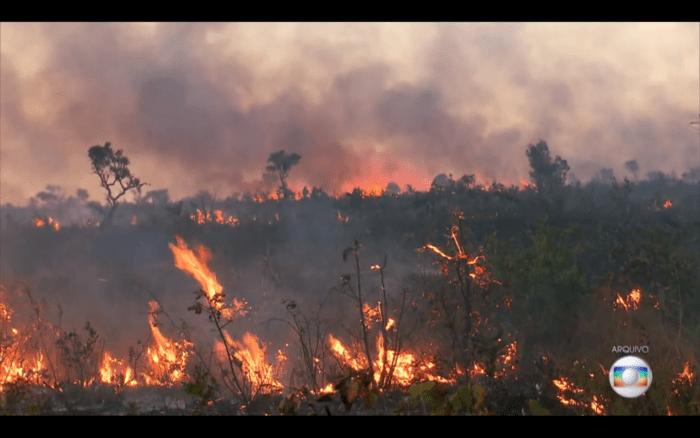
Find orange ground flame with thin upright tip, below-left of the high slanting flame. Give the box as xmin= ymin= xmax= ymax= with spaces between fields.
xmin=143 ymin=301 xmax=192 ymax=385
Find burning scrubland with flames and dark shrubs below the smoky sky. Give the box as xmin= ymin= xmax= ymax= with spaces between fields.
xmin=0 ymin=143 xmax=700 ymax=415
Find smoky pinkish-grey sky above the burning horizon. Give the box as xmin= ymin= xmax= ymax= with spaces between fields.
xmin=0 ymin=23 xmax=700 ymax=205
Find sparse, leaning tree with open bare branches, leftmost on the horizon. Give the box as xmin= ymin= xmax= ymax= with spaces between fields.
xmin=88 ymin=142 xmax=147 ymax=224
